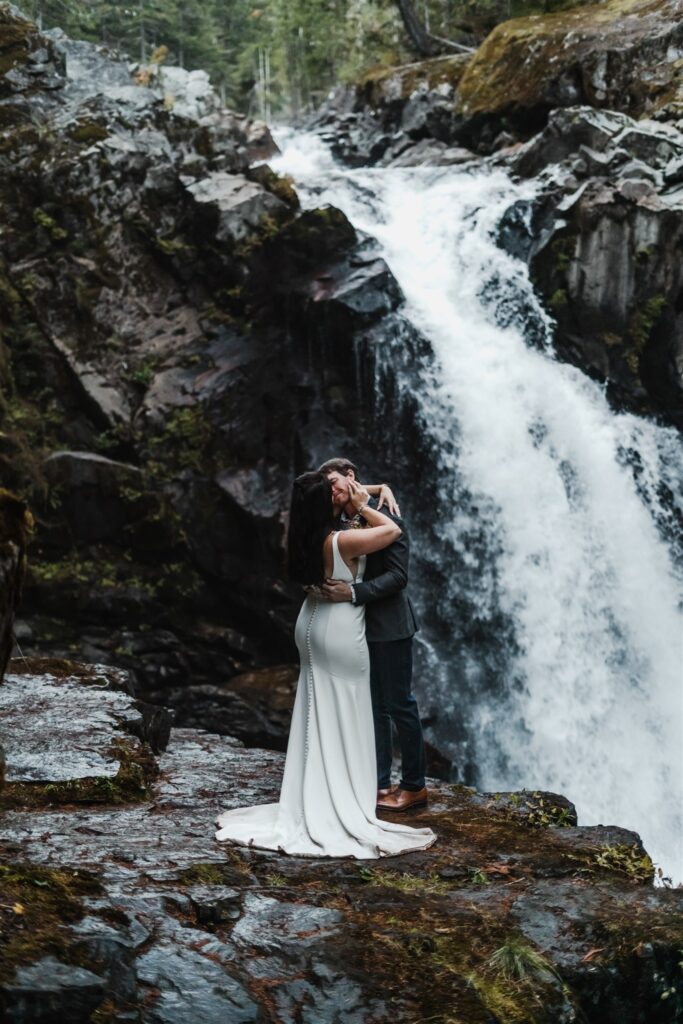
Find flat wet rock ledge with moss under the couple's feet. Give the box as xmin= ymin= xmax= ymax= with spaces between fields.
xmin=0 ymin=665 xmax=683 ymax=1024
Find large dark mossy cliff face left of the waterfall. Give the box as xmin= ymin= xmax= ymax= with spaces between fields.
xmin=0 ymin=7 xmax=421 ymax=714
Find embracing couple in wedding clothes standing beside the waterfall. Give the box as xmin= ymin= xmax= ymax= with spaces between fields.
xmin=215 ymin=459 xmax=436 ymax=860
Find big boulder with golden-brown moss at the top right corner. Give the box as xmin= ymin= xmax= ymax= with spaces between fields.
xmin=457 ymin=0 xmax=683 ymax=131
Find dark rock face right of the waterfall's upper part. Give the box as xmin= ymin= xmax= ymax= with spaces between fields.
xmin=501 ymin=108 xmax=683 ymax=426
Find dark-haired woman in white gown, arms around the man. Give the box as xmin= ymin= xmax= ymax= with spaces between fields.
xmin=215 ymin=472 xmax=436 ymax=860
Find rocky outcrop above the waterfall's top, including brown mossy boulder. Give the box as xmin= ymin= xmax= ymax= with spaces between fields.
xmin=312 ymin=0 xmax=683 ymax=166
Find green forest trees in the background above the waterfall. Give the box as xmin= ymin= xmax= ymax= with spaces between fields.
xmin=19 ymin=0 xmax=583 ymax=119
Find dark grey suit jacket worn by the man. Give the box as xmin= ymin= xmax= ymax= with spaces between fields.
xmin=335 ymin=499 xmax=420 ymax=641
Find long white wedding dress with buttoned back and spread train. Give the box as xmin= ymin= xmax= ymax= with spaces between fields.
xmin=215 ymin=534 xmax=436 ymax=860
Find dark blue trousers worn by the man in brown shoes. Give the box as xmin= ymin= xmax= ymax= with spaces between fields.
xmin=368 ymin=637 xmax=425 ymax=791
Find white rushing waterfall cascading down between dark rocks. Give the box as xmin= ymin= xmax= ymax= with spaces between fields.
xmin=270 ymin=129 xmax=683 ymax=883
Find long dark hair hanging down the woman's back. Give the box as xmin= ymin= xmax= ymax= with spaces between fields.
xmin=287 ymin=472 xmax=334 ymax=586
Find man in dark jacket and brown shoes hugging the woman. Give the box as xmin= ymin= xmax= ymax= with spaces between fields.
xmin=318 ymin=459 xmax=427 ymax=811
